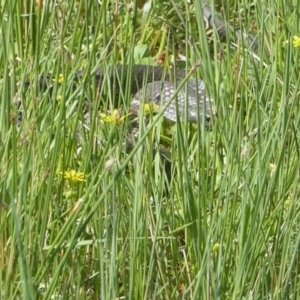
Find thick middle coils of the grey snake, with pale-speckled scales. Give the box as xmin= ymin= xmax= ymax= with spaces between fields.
xmin=77 ymin=65 xmax=216 ymax=127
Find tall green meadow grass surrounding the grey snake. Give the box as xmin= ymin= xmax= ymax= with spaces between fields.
xmin=0 ymin=0 xmax=300 ymax=299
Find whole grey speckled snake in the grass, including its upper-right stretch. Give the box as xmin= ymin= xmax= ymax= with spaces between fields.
xmin=20 ymin=0 xmax=259 ymax=127
